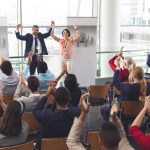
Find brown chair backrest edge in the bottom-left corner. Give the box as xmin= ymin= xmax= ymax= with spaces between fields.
xmin=0 ymin=141 xmax=34 ymax=150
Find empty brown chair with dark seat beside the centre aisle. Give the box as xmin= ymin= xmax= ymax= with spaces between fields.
xmin=89 ymin=84 xmax=110 ymax=106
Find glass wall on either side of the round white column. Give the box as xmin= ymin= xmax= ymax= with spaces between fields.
xmin=97 ymin=0 xmax=150 ymax=76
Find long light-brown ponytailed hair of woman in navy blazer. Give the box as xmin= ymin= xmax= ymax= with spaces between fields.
xmin=133 ymin=67 xmax=147 ymax=101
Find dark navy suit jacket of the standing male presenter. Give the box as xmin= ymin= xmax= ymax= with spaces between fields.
xmin=16 ymin=28 xmax=52 ymax=57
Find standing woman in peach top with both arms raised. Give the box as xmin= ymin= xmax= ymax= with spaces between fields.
xmin=51 ymin=21 xmax=80 ymax=73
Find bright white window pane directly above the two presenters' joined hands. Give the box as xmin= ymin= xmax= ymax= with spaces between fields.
xmin=22 ymin=0 xmax=68 ymax=25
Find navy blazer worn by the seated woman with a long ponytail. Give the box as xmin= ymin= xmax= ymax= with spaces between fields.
xmin=113 ymin=70 xmax=150 ymax=102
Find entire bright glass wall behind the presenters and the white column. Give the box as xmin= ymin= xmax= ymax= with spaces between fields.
xmin=0 ymin=0 xmax=150 ymax=76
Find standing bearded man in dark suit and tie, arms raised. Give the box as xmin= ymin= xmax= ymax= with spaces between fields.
xmin=16 ymin=24 xmax=52 ymax=75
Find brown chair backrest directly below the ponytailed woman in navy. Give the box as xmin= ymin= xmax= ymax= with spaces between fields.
xmin=122 ymin=101 xmax=144 ymax=116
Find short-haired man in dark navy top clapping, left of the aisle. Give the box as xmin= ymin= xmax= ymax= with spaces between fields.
xmin=33 ymin=82 xmax=80 ymax=149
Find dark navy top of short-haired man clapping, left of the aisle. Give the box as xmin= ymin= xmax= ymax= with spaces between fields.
xmin=33 ymin=96 xmax=81 ymax=149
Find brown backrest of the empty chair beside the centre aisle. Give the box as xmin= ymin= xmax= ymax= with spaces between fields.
xmin=89 ymin=84 xmax=110 ymax=99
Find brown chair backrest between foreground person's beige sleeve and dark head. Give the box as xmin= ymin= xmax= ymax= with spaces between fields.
xmin=87 ymin=131 xmax=101 ymax=150
